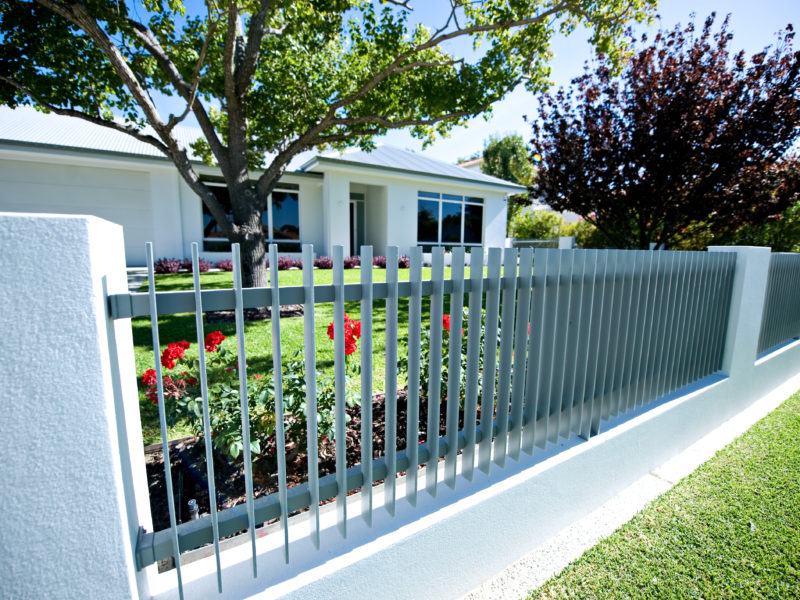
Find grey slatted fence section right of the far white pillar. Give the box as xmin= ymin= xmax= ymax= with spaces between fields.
xmin=758 ymin=253 xmax=800 ymax=354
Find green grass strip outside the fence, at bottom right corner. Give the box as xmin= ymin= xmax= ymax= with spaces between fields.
xmin=528 ymin=393 xmax=800 ymax=599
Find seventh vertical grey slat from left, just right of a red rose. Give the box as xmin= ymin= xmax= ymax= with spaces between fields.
xmin=361 ymin=246 xmax=376 ymax=527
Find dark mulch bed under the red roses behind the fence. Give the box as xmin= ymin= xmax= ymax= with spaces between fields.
xmin=145 ymin=390 xmax=476 ymax=531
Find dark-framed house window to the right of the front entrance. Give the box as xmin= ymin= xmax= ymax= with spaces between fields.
xmin=417 ymin=192 xmax=483 ymax=250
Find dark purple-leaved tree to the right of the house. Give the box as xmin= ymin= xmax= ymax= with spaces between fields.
xmin=531 ymin=14 xmax=800 ymax=248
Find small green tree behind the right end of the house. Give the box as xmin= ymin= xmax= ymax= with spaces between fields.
xmin=481 ymin=134 xmax=536 ymax=231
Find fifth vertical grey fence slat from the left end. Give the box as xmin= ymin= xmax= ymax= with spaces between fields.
xmin=303 ymin=244 xmax=319 ymax=550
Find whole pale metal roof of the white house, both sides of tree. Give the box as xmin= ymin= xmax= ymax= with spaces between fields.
xmin=0 ymin=106 xmax=525 ymax=191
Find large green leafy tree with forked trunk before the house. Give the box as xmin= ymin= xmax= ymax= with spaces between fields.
xmin=0 ymin=0 xmax=656 ymax=286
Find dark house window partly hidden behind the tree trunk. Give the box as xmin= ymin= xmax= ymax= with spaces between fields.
xmin=203 ymin=182 xmax=300 ymax=252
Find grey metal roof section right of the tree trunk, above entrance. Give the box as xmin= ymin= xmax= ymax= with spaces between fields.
xmin=300 ymin=146 xmax=525 ymax=191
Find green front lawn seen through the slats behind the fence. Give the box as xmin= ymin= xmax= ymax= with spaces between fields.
xmin=132 ymin=269 xmax=478 ymax=444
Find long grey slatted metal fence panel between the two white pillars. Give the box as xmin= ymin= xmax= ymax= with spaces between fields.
xmin=109 ymin=245 xmax=736 ymax=589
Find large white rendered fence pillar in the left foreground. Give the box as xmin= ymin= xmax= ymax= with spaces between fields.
xmin=0 ymin=213 xmax=149 ymax=598
